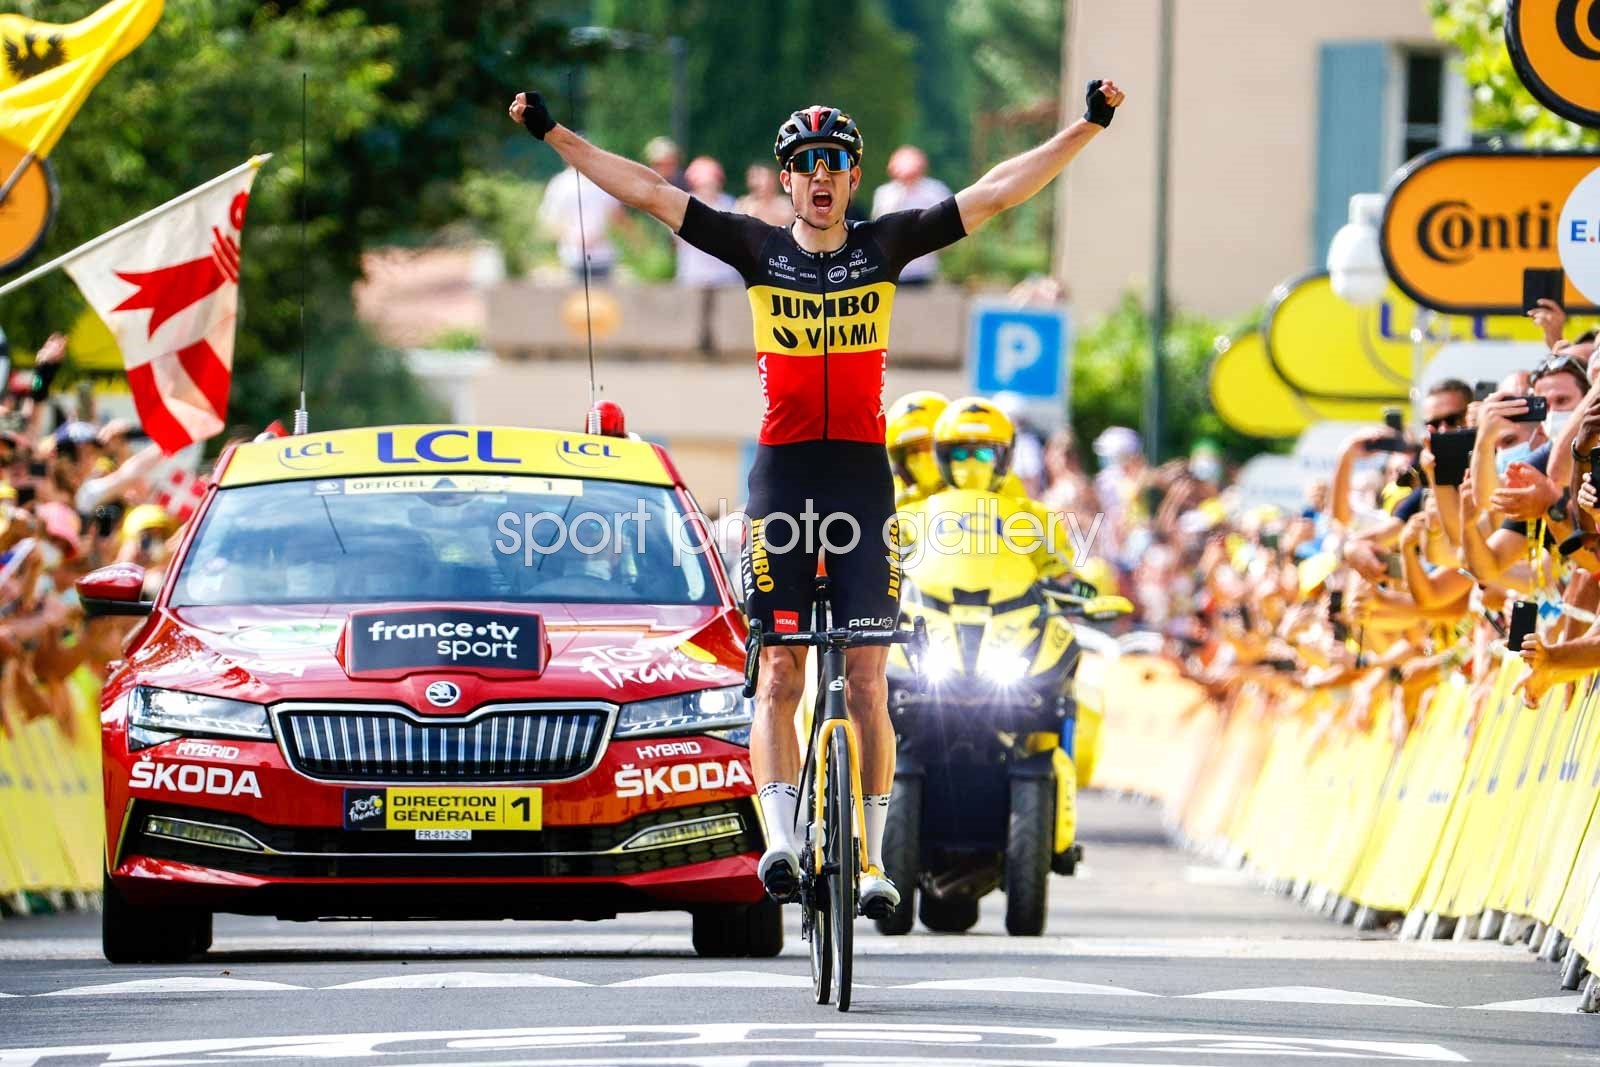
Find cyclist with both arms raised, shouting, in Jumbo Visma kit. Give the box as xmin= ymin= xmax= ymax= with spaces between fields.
xmin=509 ymin=80 xmax=1123 ymax=917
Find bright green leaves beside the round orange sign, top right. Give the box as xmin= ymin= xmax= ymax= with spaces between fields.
xmin=1427 ymin=0 xmax=1600 ymax=149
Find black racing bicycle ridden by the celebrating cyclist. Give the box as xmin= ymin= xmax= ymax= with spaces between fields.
xmin=744 ymin=574 xmax=928 ymax=1011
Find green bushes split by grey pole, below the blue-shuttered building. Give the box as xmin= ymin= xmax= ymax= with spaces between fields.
xmin=1072 ymin=293 xmax=1261 ymax=458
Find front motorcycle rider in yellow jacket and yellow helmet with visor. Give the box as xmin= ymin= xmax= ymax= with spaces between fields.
xmin=901 ymin=397 xmax=1074 ymax=581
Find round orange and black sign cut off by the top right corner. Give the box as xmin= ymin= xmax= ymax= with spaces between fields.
xmin=1506 ymin=0 xmax=1600 ymax=130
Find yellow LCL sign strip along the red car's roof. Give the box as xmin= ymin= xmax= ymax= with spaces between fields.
xmin=222 ymin=426 xmax=672 ymax=486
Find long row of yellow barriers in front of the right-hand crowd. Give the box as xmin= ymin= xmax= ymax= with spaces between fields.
xmin=1098 ymin=656 xmax=1600 ymax=998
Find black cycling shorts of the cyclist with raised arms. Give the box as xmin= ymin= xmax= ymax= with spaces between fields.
xmin=741 ymin=440 xmax=901 ymax=633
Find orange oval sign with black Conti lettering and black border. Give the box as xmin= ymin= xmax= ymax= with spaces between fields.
xmin=1382 ymin=150 xmax=1600 ymax=315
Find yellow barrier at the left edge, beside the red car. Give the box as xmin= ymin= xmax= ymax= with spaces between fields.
xmin=0 ymin=670 xmax=106 ymax=897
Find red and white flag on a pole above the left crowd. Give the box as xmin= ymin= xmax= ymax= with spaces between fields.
xmin=62 ymin=166 xmax=259 ymax=456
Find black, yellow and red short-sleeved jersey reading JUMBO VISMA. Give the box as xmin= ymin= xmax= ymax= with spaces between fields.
xmin=678 ymin=197 xmax=966 ymax=445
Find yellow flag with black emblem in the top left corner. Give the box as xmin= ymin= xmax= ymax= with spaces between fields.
xmin=0 ymin=0 xmax=163 ymax=158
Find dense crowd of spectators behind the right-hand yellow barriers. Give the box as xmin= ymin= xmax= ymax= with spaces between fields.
xmin=1081 ymin=304 xmax=1600 ymax=748
